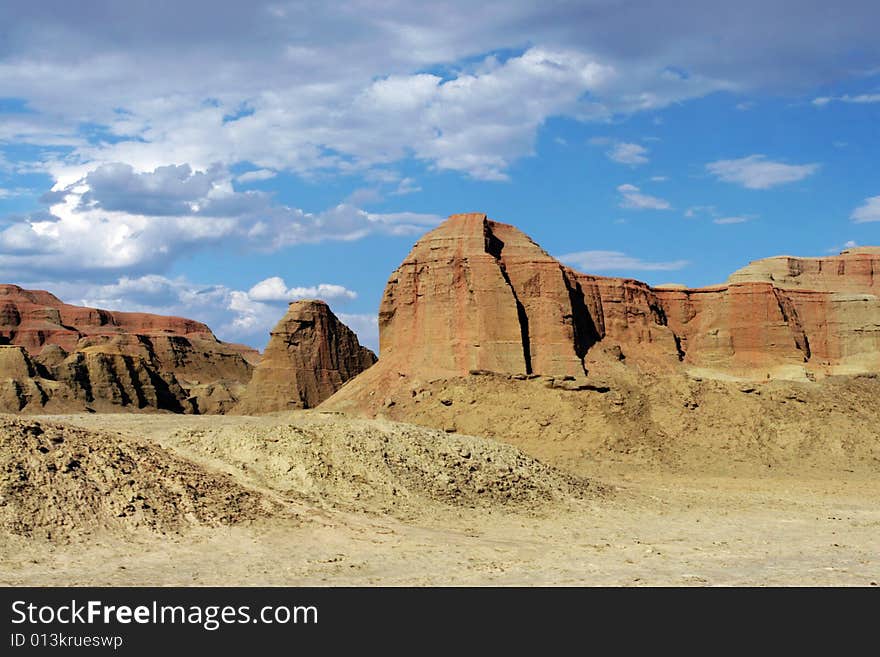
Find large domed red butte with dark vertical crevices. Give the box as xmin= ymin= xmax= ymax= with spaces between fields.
xmin=368 ymin=214 xmax=680 ymax=376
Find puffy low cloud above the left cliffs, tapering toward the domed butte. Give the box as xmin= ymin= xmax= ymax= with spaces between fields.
xmin=0 ymin=164 xmax=442 ymax=279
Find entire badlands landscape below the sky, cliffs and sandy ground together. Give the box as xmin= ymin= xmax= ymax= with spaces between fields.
xmin=0 ymin=214 xmax=880 ymax=586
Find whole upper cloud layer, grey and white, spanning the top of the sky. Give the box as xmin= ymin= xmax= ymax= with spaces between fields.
xmin=0 ymin=0 xmax=880 ymax=187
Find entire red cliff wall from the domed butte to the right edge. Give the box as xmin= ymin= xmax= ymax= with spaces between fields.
xmin=331 ymin=214 xmax=880 ymax=406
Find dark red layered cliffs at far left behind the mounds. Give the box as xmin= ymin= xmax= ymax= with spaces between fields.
xmin=0 ymin=285 xmax=254 ymax=413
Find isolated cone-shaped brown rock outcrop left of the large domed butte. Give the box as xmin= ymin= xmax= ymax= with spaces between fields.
xmin=236 ymin=300 xmax=376 ymax=414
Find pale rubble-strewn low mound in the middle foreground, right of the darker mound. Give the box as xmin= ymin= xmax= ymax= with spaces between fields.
xmin=169 ymin=413 xmax=591 ymax=514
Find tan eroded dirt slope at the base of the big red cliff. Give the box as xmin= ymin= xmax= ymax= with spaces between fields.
xmin=321 ymin=367 xmax=880 ymax=474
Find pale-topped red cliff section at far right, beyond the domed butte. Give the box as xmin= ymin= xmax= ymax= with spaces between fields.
xmin=657 ymin=247 xmax=880 ymax=378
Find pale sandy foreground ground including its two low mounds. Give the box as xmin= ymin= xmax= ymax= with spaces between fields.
xmin=0 ymin=405 xmax=880 ymax=586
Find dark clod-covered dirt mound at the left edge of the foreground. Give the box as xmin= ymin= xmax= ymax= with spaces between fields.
xmin=0 ymin=417 xmax=270 ymax=542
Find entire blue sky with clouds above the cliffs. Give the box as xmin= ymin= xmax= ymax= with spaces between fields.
xmin=0 ymin=0 xmax=880 ymax=348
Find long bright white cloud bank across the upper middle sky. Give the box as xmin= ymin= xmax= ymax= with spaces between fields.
xmin=27 ymin=46 xmax=624 ymax=183
